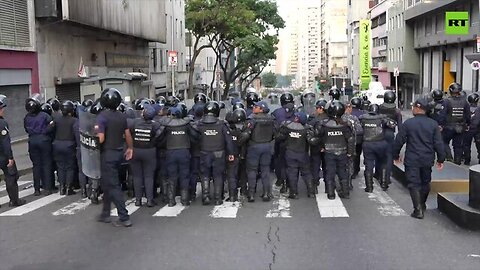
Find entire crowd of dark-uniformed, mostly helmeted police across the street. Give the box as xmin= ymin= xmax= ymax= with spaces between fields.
xmin=0 ymin=83 xmax=472 ymax=226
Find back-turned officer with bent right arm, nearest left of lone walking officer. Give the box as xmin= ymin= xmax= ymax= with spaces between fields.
xmin=359 ymin=104 xmax=395 ymax=193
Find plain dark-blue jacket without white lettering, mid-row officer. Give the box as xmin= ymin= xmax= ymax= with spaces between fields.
xmin=247 ymin=113 xmax=277 ymax=145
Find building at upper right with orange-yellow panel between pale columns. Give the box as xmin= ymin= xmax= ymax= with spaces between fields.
xmin=403 ymin=0 xmax=480 ymax=95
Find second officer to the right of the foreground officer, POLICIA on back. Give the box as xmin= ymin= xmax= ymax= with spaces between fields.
xmin=161 ymin=106 xmax=198 ymax=207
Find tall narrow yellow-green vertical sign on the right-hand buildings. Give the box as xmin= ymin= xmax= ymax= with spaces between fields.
xmin=359 ymin=20 xmax=372 ymax=90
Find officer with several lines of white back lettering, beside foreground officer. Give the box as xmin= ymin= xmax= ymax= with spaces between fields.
xmin=130 ymin=105 xmax=160 ymax=207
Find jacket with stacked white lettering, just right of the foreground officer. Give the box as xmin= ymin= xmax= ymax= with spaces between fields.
xmin=129 ymin=118 xmax=160 ymax=149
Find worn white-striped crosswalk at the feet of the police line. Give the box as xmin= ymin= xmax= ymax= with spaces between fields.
xmin=0 ymin=181 xmax=407 ymax=219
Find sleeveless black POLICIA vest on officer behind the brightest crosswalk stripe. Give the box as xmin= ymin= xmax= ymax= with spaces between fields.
xmin=322 ymin=120 xmax=348 ymax=155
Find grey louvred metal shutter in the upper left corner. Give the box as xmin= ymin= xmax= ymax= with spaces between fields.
xmin=0 ymin=0 xmax=31 ymax=47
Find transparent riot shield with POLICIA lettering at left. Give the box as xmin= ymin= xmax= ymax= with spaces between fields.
xmin=78 ymin=111 xmax=101 ymax=179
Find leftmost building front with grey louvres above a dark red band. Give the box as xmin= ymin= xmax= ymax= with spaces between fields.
xmin=0 ymin=0 xmax=40 ymax=138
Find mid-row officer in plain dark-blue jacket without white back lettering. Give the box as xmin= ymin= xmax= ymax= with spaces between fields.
xmin=247 ymin=101 xmax=276 ymax=202
